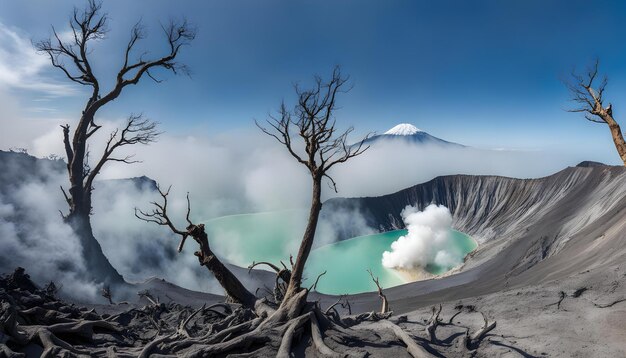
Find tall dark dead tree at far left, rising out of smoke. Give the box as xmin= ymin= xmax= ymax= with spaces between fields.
xmin=35 ymin=0 xmax=195 ymax=283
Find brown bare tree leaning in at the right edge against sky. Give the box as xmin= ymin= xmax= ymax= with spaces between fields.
xmin=566 ymin=60 xmax=626 ymax=166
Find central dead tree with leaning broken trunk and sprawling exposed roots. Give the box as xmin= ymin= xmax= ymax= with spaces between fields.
xmin=135 ymin=69 xmax=482 ymax=357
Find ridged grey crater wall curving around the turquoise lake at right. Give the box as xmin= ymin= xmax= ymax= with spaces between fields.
xmin=325 ymin=164 xmax=626 ymax=309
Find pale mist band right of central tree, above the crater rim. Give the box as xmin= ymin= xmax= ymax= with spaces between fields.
xmin=332 ymin=141 xmax=583 ymax=197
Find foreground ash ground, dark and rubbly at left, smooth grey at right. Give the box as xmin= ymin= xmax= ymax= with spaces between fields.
xmin=0 ymin=265 xmax=626 ymax=358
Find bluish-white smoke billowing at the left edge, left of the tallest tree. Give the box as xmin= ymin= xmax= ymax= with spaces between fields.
xmin=0 ymin=163 xmax=99 ymax=301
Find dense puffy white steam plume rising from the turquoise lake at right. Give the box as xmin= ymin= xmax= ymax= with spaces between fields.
xmin=382 ymin=204 xmax=464 ymax=269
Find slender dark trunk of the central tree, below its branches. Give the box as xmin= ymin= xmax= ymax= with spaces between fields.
xmin=283 ymin=176 xmax=322 ymax=303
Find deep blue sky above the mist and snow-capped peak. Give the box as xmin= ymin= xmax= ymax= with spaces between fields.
xmin=0 ymin=0 xmax=626 ymax=164
